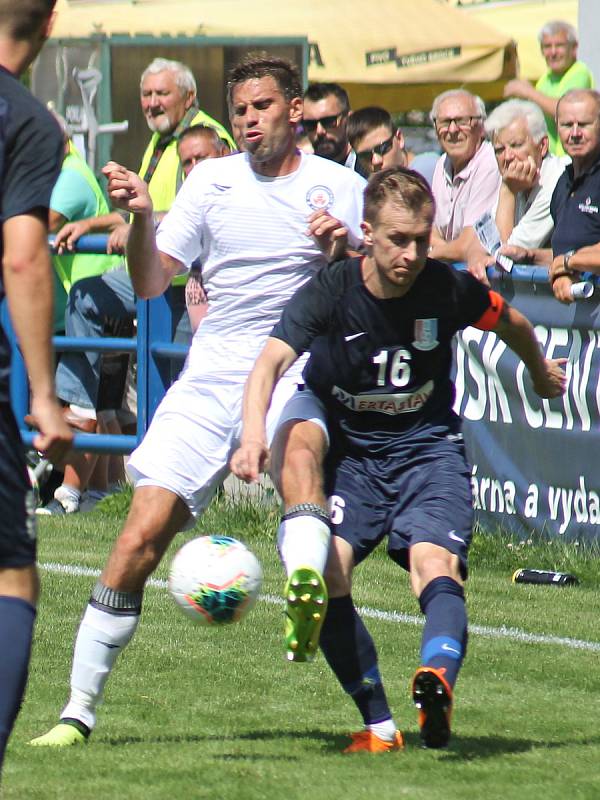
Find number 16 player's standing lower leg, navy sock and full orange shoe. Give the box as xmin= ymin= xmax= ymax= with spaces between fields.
xmin=321 ymin=536 xmax=404 ymax=753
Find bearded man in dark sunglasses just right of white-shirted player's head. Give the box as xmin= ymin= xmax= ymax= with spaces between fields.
xmin=302 ymin=83 xmax=356 ymax=169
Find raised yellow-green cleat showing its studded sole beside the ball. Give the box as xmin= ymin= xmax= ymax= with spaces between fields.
xmin=285 ymin=567 xmax=327 ymax=661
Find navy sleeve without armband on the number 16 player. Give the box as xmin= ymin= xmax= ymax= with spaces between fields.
xmin=271 ymin=261 xmax=346 ymax=355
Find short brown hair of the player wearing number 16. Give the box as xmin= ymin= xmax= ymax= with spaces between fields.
xmin=363 ymin=167 xmax=435 ymax=225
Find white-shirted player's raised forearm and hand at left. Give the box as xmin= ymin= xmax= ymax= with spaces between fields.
xmin=102 ymin=161 xmax=184 ymax=299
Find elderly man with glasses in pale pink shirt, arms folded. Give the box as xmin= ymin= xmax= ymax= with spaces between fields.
xmin=430 ymin=89 xmax=502 ymax=278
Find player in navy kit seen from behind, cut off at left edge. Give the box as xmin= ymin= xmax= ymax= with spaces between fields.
xmin=0 ymin=0 xmax=72 ymax=766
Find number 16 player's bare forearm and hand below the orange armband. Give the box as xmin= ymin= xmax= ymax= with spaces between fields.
xmin=493 ymin=302 xmax=567 ymax=398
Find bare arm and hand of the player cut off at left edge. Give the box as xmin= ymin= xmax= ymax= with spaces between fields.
xmin=2 ymin=214 xmax=73 ymax=461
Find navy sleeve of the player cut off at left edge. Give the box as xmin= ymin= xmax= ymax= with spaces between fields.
xmin=1 ymin=82 xmax=63 ymax=220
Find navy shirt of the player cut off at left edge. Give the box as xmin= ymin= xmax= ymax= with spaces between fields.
xmin=0 ymin=66 xmax=63 ymax=402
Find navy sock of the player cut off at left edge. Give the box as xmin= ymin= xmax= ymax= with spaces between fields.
xmin=0 ymin=595 xmax=35 ymax=766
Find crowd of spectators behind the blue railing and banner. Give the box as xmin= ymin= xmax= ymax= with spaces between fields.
xmin=30 ymin=21 xmax=600 ymax=514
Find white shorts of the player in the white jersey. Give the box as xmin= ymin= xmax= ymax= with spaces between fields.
xmin=127 ymin=374 xmax=300 ymax=525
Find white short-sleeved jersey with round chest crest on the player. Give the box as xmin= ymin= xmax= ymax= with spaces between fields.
xmin=157 ymin=153 xmax=365 ymax=376
